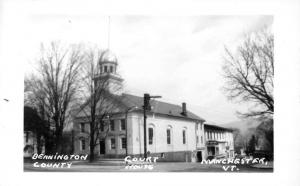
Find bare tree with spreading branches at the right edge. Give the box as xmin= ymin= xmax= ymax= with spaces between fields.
xmin=223 ymin=31 xmax=274 ymax=117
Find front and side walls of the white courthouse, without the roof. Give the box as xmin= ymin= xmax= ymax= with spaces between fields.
xmin=74 ymin=113 xmax=205 ymax=161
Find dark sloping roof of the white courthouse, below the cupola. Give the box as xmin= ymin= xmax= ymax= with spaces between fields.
xmin=121 ymin=94 xmax=205 ymax=121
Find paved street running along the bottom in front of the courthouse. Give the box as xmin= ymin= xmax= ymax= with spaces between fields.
xmin=24 ymin=161 xmax=273 ymax=172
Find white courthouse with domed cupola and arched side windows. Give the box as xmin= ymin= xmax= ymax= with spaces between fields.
xmin=74 ymin=51 xmax=234 ymax=162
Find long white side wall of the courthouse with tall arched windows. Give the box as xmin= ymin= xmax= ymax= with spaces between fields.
xmin=128 ymin=113 xmax=205 ymax=159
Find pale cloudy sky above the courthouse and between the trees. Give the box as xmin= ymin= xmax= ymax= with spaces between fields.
xmin=3 ymin=2 xmax=273 ymax=124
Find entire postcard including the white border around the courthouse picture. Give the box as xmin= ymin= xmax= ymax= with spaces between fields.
xmin=0 ymin=0 xmax=300 ymax=185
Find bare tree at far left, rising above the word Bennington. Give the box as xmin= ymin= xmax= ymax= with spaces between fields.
xmin=25 ymin=42 xmax=83 ymax=152
